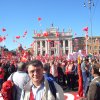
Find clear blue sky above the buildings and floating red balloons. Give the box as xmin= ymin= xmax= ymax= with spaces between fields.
xmin=0 ymin=0 xmax=100 ymax=50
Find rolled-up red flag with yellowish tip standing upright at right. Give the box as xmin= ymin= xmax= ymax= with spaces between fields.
xmin=78 ymin=56 xmax=83 ymax=97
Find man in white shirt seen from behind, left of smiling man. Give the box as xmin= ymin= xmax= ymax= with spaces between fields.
xmin=8 ymin=62 xmax=30 ymax=100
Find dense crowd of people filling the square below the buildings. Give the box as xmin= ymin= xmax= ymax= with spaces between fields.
xmin=0 ymin=52 xmax=100 ymax=100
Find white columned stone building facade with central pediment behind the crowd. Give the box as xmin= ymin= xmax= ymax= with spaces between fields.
xmin=33 ymin=26 xmax=72 ymax=56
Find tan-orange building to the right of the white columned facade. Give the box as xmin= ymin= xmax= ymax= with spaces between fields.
xmin=72 ymin=36 xmax=100 ymax=55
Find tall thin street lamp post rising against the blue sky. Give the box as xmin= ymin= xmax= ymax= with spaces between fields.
xmin=84 ymin=0 xmax=94 ymax=53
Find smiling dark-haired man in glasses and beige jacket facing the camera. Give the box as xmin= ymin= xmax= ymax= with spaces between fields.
xmin=21 ymin=60 xmax=64 ymax=100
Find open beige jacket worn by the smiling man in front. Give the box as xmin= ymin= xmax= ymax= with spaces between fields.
xmin=21 ymin=79 xmax=64 ymax=100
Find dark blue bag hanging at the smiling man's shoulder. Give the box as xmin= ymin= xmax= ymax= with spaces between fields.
xmin=46 ymin=77 xmax=57 ymax=99
